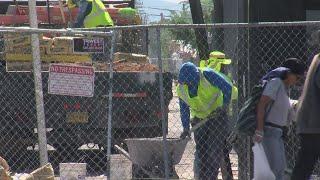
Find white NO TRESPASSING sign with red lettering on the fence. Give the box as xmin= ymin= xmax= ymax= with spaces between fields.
xmin=48 ymin=64 xmax=94 ymax=97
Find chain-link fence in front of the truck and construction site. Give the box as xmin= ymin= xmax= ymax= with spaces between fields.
xmin=0 ymin=22 xmax=320 ymax=180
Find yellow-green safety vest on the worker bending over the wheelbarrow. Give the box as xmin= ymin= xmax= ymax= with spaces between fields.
xmin=177 ymin=69 xmax=223 ymax=119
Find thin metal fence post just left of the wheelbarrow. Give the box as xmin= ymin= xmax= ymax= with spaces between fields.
xmin=107 ymin=30 xmax=116 ymax=178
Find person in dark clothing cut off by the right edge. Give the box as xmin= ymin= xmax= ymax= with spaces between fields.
xmin=291 ymin=54 xmax=320 ymax=180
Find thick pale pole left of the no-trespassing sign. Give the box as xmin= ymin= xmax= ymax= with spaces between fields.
xmin=29 ymin=0 xmax=48 ymax=166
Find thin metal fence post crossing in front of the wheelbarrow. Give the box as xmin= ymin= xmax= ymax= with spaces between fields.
xmin=156 ymin=27 xmax=169 ymax=179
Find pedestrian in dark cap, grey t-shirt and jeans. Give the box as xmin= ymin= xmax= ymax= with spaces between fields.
xmin=253 ymin=58 xmax=305 ymax=180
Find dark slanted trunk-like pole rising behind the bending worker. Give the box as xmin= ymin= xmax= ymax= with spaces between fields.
xmin=189 ymin=0 xmax=209 ymax=59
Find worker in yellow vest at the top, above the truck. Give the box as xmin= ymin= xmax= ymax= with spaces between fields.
xmin=67 ymin=0 xmax=113 ymax=28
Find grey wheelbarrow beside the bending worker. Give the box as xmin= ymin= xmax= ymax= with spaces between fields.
xmin=115 ymin=122 xmax=204 ymax=179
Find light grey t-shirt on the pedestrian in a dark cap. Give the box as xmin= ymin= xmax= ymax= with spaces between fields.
xmin=262 ymin=78 xmax=291 ymax=126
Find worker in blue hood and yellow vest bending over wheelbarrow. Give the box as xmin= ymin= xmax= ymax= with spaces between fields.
xmin=177 ymin=62 xmax=232 ymax=179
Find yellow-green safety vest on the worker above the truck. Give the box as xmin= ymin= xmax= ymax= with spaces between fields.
xmin=83 ymin=0 xmax=113 ymax=28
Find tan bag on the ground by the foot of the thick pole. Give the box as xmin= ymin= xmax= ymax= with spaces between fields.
xmin=26 ymin=163 xmax=54 ymax=180
